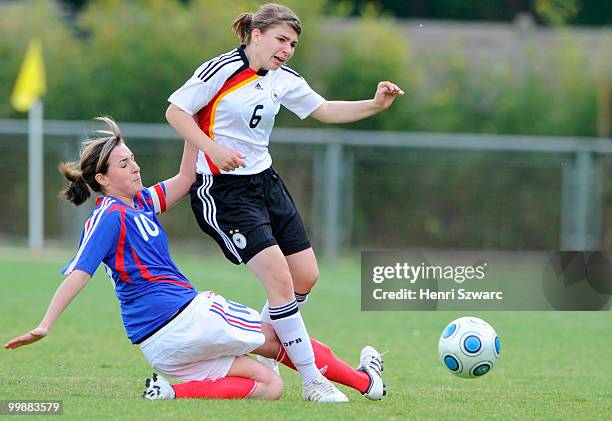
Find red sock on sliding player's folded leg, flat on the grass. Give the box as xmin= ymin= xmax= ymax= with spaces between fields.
xmin=172 ymin=377 xmax=257 ymax=399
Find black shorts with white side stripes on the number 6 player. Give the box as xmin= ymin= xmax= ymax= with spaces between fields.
xmin=191 ymin=167 xmax=310 ymax=265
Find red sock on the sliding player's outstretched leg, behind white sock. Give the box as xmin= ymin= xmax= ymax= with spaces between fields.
xmin=277 ymin=338 xmax=370 ymax=393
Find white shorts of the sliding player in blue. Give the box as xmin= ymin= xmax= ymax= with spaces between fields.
xmin=140 ymin=291 xmax=265 ymax=382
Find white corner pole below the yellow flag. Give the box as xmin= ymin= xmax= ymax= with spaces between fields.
xmin=28 ymin=98 xmax=44 ymax=250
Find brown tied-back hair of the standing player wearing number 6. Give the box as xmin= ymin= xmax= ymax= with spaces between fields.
xmin=232 ymin=3 xmax=302 ymax=45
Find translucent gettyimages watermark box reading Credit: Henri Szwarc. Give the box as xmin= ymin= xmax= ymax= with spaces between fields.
xmin=361 ymin=251 xmax=612 ymax=310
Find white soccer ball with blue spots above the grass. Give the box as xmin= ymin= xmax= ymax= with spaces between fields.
xmin=438 ymin=317 xmax=500 ymax=379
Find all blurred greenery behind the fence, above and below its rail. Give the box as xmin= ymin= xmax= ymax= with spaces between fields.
xmin=0 ymin=0 xmax=612 ymax=248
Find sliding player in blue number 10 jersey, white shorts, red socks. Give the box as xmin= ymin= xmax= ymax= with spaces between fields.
xmin=4 ymin=118 xmax=384 ymax=402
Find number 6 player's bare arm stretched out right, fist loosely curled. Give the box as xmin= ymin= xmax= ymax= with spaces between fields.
xmin=310 ymin=81 xmax=404 ymax=123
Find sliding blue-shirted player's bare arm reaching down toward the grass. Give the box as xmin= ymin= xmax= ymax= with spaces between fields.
xmin=4 ymin=270 xmax=90 ymax=349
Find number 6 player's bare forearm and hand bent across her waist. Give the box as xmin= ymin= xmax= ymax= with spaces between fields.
xmin=166 ymin=104 xmax=246 ymax=171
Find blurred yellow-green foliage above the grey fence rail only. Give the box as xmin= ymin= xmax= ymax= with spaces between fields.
xmin=0 ymin=0 xmax=612 ymax=136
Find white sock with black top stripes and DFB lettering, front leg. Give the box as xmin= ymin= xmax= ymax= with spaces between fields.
xmin=268 ymin=300 xmax=321 ymax=385
